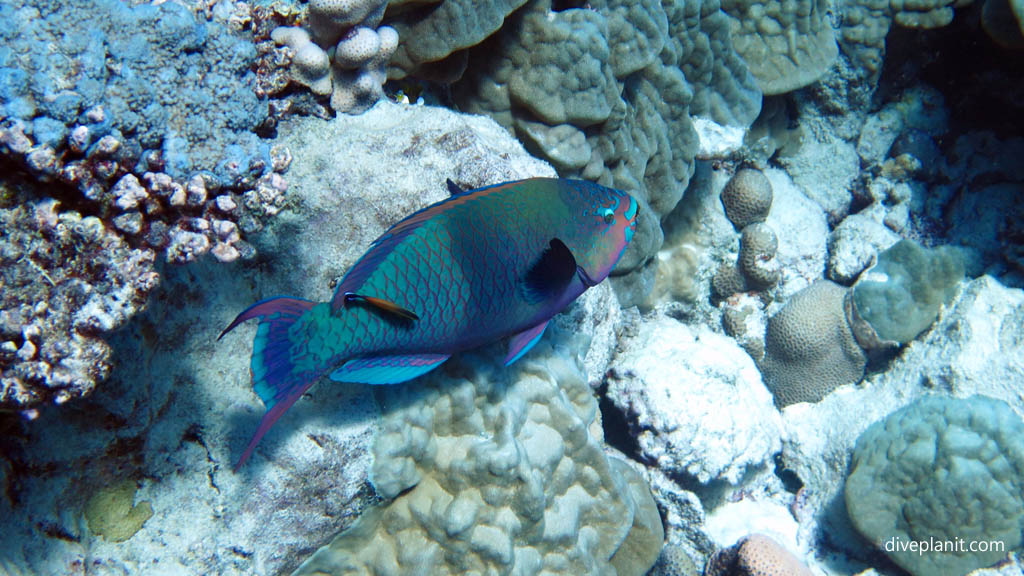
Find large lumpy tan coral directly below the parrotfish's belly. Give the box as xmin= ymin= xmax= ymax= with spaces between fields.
xmin=297 ymin=340 xmax=664 ymax=576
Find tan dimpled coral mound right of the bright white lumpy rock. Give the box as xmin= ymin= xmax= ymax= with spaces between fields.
xmin=759 ymin=280 xmax=867 ymax=408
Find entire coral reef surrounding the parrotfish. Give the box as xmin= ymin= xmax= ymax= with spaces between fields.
xmin=0 ymin=0 xmax=1024 ymax=576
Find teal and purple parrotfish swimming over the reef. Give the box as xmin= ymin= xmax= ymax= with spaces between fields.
xmin=220 ymin=178 xmax=638 ymax=469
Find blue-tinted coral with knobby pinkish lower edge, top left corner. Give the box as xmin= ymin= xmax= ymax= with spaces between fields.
xmin=0 ymin=0 xmax=290 ymax=262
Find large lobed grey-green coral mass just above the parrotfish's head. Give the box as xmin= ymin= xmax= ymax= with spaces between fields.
xmin=455 ymin=1 xmax=759 ymax=272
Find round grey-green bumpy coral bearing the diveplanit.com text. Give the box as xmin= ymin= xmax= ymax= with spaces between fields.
xmin=846 ymin=396 xmax=1024 ymax=576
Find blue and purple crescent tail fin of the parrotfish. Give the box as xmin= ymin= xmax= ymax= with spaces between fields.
xmin=217 ymin=297 xmax=321 ymax=471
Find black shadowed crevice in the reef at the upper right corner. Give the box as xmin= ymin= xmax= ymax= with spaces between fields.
xmin=880 ymin=3 xmax=1024 ymax=145
